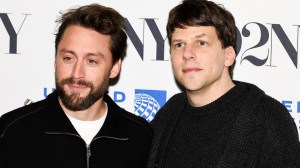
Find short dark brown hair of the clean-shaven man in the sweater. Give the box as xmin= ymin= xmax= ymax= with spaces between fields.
xmin=166 ymin=0 xmax=236 ymax=77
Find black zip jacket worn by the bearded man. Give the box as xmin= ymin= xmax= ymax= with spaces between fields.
xmin=0 ymin=92 xmax=153 ymax=168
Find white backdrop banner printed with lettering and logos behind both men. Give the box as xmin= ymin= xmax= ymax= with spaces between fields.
xmin=0 ymin=0 xmax=300 ymax=136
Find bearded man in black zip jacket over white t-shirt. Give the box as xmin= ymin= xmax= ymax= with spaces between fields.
xmin=0 ymin=4 xmax=152 ymax=168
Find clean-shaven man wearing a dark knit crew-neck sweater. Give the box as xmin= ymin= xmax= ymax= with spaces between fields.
xmin=148 ymin=0 xmax=300 ymax=168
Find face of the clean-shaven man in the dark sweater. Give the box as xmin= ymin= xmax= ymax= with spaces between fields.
xmin=170 ymin=26 xmax=232 ymax=93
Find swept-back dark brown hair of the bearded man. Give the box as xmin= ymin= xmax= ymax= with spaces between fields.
xmin=55 ymin=4 xmax=127 ymax=63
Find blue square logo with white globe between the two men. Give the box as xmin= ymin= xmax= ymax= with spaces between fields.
xmin=134 ymin=89 xmax=167 ymax=122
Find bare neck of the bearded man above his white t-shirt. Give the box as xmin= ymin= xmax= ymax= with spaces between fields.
xmin=58 ymin=98 xmax=107 ymax=121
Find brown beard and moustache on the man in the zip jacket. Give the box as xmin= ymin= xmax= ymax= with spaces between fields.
xmin=55 ymin=77 xmax=109 ymax=111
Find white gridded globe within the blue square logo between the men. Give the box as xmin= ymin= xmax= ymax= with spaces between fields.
xmin=134 ymin=93 xmax=160 ymax=122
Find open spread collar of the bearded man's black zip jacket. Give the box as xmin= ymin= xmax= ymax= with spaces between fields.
xmin=44 ymin=91 xmax=129 ymax=140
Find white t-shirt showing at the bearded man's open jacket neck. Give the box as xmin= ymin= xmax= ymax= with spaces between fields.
xmin=67 ymin=103 xmax=107 ymax=145
